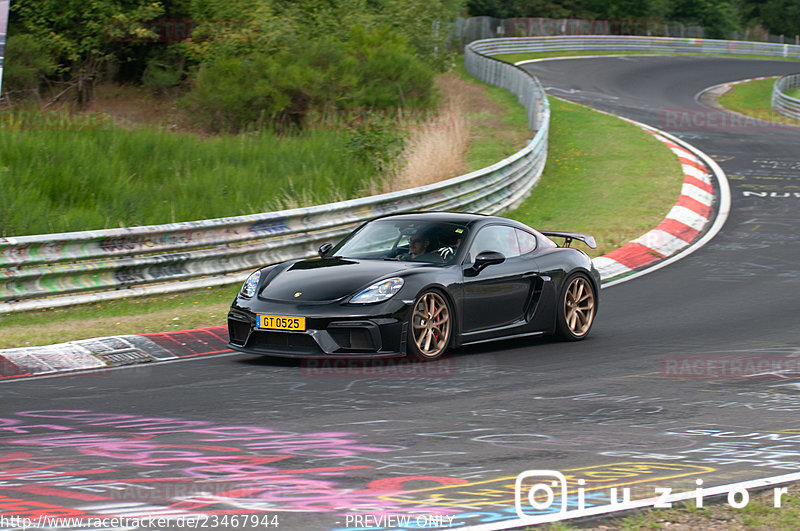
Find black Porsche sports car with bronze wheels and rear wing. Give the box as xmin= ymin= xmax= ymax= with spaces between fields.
xmin=228 ymin=212 xmax=600 ymax=360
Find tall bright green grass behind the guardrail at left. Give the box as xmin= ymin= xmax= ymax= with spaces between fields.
xmin=0 ymin=111 xmax=374 ymax=236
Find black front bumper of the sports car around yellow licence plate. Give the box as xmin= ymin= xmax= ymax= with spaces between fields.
xmin=228 ymin=298 xmax=411 ymax=359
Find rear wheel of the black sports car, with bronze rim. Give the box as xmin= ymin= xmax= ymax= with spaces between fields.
xmin=556 ymin=273 xmax=597 ymax=341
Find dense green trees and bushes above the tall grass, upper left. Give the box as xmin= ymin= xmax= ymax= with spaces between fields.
xmin=4 ymin=0 xmax=463 ymax=131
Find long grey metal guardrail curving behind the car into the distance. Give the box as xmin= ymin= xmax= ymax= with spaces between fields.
xmin=0 ymin=36 xmax=800 ymax=312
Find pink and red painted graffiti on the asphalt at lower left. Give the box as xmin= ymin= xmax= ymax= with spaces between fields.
xmin=0 ymin=410 xmax=476 ymax=519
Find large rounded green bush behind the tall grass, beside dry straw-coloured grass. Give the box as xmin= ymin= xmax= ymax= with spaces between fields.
xmin=185 ymin=27 xmax=434 ymax=132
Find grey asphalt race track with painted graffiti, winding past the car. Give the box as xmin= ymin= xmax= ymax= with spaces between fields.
xmin=0 ymin=56 xmax=800 ymax=530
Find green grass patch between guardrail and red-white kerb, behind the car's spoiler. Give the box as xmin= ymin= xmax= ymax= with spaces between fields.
xmin=507 ymin=98 xmax=683 ymax=256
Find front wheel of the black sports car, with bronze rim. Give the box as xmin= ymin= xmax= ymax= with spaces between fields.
xmin=407 ymin=290 xmax=453 ymax=361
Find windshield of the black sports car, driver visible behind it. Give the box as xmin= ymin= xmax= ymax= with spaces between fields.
xmin=331 ymin=220 xmax=467 ymax=264
